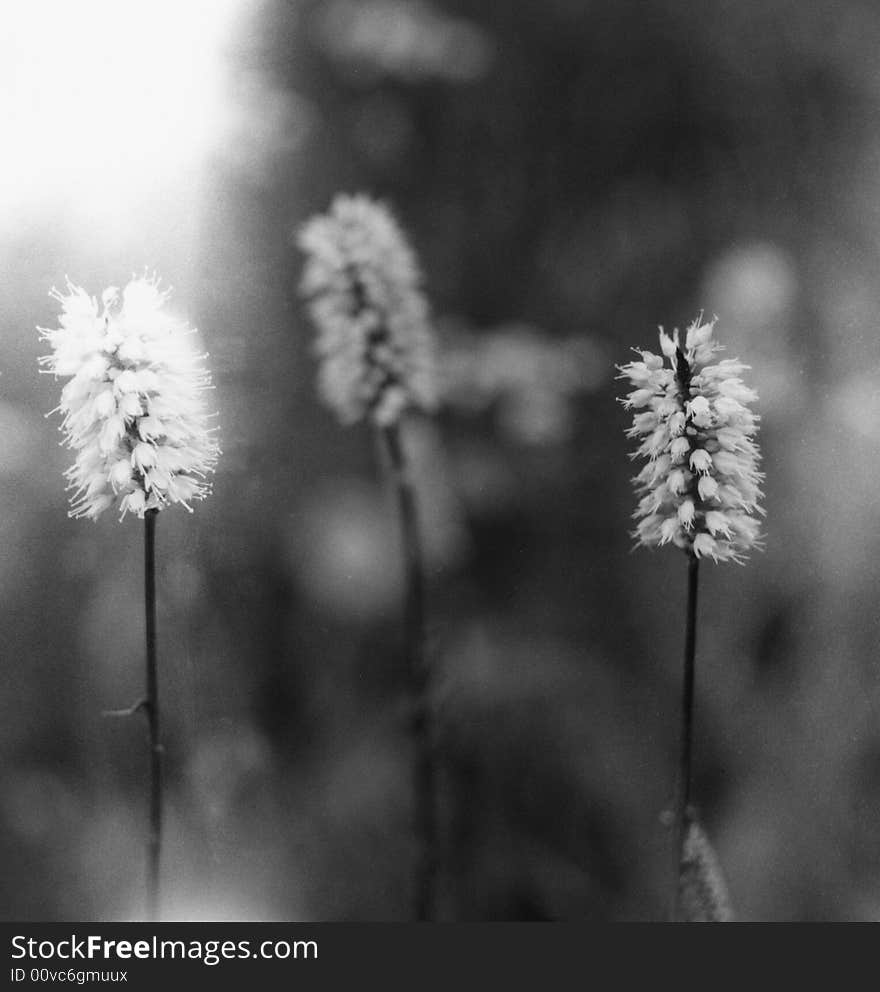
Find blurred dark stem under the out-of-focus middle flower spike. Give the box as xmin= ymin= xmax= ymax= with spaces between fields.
xmin=381 ymin=425 xmax=438 ymax=921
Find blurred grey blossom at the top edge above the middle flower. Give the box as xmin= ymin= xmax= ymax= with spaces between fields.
xmin=314 ymin=0 xmax=493 ymax=83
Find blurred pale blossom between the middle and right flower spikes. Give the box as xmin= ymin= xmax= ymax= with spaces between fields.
xmin=441 ymin=325 xmax=602 ymax=444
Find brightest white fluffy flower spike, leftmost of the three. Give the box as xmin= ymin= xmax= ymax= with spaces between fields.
xmin=39 ymin=276 xmax=219 ymax=520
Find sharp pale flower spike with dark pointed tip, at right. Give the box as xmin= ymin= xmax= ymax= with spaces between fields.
xmin=619 ymin=319 xmax=763 ymax=562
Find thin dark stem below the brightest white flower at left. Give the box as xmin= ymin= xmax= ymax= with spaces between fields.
xmin=144 ymin=510 xmax=162 ymax=922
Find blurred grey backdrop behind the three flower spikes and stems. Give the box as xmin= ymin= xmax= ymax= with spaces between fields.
xmin=0 ymin=0 xmax=880 ymax=920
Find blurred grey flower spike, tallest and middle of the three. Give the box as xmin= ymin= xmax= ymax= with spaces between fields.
xmin=297 ymin=195 xmax=436 ymax=426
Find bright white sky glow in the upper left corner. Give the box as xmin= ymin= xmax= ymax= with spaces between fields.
xmin=0 ymin=0 xmax=244 ymax=226
